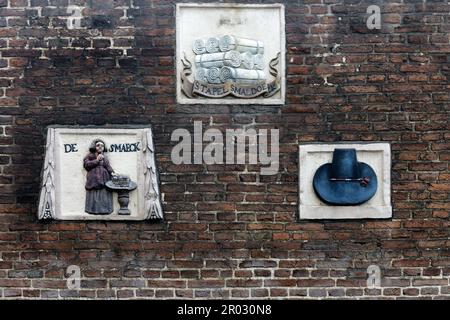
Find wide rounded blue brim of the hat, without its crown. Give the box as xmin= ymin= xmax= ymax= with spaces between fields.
xmin=313 ymin=162 xmax=378 ymax=206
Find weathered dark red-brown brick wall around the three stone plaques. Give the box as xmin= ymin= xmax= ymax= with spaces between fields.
xmin=0 ymin=0 xmax=450 ymax=298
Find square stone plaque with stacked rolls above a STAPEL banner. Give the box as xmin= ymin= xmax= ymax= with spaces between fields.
xmin=177 ymin=3 xmax=285 ymax=104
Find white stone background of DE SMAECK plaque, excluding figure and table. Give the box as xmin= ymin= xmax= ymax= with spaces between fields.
xmin=38 ymin=126 xmax=163 ymax=220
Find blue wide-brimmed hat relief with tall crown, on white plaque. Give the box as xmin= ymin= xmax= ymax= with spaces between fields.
xmin=313 ymin=149 xmax=377 ymax=205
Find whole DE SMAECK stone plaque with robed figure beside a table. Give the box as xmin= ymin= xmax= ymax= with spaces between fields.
xmin=38 ymin=127 xmax=163 ymax=220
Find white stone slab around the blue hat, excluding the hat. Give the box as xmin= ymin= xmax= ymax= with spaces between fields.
xmin=299 ymin=143 xmax=392 ymax=219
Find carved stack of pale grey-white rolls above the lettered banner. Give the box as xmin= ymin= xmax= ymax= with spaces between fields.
xmin=193 ymin=35 xmax=266 ymax=85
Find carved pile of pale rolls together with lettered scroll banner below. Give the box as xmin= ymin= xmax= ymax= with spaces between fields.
xmin=181 ymin=34 xmax=280 ymax=99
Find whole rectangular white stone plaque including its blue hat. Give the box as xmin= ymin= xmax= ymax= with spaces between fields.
xmin=299 ymin=143 xmax=392 ymax=219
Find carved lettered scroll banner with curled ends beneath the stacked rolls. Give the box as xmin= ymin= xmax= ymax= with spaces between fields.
xmin=181 ymin=53 xmax=281 ymax=99
